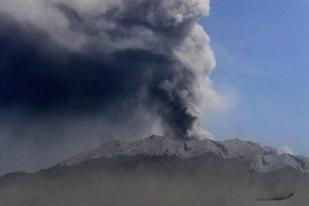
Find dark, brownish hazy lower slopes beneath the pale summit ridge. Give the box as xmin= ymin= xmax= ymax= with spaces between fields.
xmin=0 ymin=157 xmax=309 ymax=206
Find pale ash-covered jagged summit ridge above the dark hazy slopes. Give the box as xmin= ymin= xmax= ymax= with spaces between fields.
xmin=57 ymin=135 xmax=309 ymax=173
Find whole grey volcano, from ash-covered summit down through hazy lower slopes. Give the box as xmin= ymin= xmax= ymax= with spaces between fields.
xmin=0 ymin=136 xmax=309 ymax=206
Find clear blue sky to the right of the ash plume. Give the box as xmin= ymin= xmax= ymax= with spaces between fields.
xmin=202 ymin=0 xmax=309 ymax=155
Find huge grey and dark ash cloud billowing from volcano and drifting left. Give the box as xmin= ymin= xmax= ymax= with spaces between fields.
xmin=0 ymin=0 xmax=218 ymax=172
